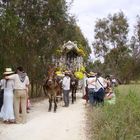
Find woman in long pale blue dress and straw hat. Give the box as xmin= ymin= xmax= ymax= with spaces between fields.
xmin=0 ymin=68 xmax=15 ymax=123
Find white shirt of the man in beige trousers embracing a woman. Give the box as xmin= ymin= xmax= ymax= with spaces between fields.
xmin=7 ymin=74 xmax=29 ymax=89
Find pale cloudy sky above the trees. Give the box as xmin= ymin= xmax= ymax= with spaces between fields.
xmin=66 ymin=0 xmax=140 ymax=44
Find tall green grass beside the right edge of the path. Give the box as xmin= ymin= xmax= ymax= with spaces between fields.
xmin=87 ymin=84 xmax=140 ymax=140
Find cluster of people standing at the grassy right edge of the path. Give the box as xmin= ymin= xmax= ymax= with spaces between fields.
xmin=83 ymin=72 xmax=115 ymax=106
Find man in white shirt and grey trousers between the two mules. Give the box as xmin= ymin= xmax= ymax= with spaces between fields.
xmin=62 ymin=71 xmax=70 ymax=107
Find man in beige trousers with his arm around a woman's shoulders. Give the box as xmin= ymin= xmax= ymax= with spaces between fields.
xmin=5 ymin=67 xmax=29 ymax=123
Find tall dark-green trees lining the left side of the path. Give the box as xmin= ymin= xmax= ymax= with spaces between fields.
xmin=0 ymin=0 xmax=89 ymax=96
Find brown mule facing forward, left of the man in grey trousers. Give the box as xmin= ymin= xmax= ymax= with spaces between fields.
xmin=43 ymin=71 xmax=61 ymax=112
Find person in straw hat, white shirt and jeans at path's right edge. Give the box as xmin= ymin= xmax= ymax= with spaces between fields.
xmin=87 ymin=72 xmax=96 ymax=106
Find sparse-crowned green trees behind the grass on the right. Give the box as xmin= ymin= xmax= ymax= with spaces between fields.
xmin=93 ymin=11 xmax=140 ymax=83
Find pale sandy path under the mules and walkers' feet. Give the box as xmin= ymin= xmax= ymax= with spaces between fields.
xmin=0 ymin=94 xmax=86 ymax=140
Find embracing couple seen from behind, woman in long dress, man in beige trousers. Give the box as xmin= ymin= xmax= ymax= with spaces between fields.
xmin=0 ymin=67 xmax=29 ymax=123
